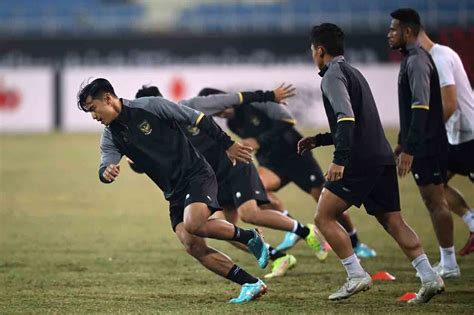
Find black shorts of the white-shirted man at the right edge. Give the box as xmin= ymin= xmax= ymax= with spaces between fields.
xmin=448 ymin=140 xmax=474 ymax=183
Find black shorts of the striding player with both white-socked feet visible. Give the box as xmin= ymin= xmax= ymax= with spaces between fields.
xmin=324 ymin=165 xmax=400 ymax=215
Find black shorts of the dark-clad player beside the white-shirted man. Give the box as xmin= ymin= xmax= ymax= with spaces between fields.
xmin=411 ymin=154 xmax=447 ymax=186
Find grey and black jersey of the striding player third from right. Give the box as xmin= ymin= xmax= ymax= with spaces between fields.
xmin=319 ymin=56 xmax=395 ymax=168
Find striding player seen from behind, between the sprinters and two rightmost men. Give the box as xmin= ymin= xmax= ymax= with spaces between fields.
xmin=298 ymin=23 xmax=444 ymax=303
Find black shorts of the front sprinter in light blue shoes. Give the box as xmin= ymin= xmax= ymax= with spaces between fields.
xmin=169 ymin=166 xmax=222 ymax=231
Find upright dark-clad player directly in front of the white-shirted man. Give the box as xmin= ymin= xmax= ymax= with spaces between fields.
xmin=387 ymin=8 xmax=461 ymax=278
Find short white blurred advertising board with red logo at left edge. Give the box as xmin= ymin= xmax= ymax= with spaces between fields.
xmin=0 ymin=67 xmax=54 ymax=132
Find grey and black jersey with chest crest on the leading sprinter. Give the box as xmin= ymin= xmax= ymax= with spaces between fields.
xmin=99 ymin=97 xmax=222 ymax=200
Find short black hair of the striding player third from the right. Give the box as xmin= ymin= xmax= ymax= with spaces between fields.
xmin=311 ymin=23 xmax=344 ymax=56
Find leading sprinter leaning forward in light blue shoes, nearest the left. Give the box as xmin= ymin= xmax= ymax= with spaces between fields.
xmin=78 ymin=78 xmax=269 ymax=303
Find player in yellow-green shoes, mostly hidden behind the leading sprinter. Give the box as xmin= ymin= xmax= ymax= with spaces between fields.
xmin=132 ymin=86 xmax=320 ymax=278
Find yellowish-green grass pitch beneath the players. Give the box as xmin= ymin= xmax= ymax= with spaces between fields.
xmin=0 ymin=133 xmax=474 ymax=314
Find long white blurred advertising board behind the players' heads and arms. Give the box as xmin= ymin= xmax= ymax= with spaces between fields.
xmin=62 ymin=64 xmax=399 ymax=131
